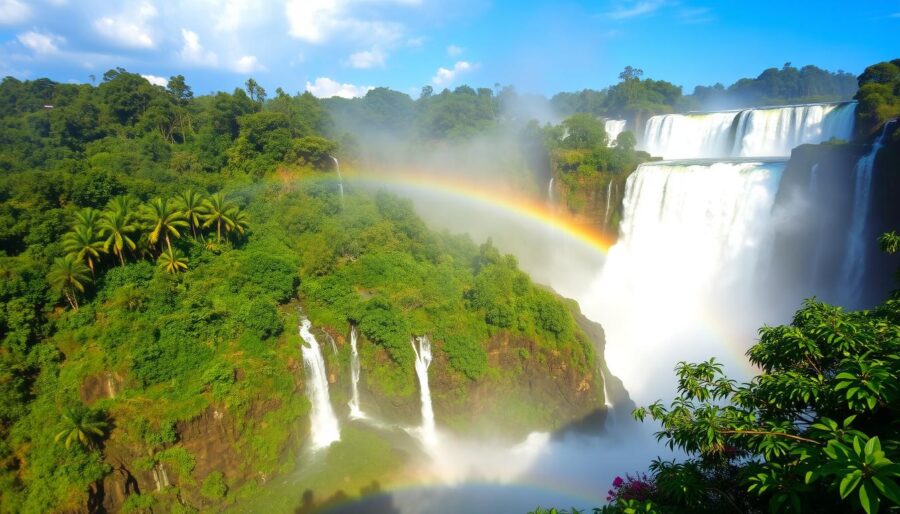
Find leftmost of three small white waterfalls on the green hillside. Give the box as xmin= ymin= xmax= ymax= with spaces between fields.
xmin=300 ymin=318 xmax=341 ymax=449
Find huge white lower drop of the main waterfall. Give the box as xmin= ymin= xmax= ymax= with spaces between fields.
xmin=582 ymin=161 xmax=784 ymax=403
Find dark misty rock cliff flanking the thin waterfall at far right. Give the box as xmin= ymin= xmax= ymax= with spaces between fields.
xmin=773 ymin=131 xmax=900 ymax=307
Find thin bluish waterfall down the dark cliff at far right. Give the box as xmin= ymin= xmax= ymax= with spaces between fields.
xmin=841 ymin=121 xmax=894 ymax=306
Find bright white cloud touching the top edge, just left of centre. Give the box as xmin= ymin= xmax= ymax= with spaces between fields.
xmin=285 ymin=0 xmax=408 ymax=47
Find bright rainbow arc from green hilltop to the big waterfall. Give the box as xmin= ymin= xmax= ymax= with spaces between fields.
xmin=349 ymin=173 xmax=614 ymax=255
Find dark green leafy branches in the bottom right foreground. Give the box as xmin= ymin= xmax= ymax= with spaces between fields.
xmin=600 ymin=232 xmax=900 ymax=514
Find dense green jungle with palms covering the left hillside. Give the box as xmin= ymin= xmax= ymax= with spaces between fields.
xmin=0 ymin=69 xmax=602 ymax=512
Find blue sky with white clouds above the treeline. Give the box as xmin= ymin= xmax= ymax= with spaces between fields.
xmin=0 ymin=0 xmax=900 ymax=96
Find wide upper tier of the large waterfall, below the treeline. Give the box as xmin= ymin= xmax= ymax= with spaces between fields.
xmin=642 ymin=102 xmax=856 ymax=159
